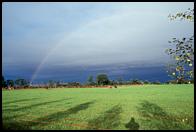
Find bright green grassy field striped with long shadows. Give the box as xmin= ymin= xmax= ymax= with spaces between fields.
xmin=2 ymin=84 xmax=194 ymax=130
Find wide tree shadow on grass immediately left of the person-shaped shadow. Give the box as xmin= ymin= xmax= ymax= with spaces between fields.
xmin=87 ymin=105 xmax=122 ymax=130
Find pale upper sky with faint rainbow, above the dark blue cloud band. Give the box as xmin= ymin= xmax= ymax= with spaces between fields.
xmin=2 ymin=2 xmax=194 ymax=82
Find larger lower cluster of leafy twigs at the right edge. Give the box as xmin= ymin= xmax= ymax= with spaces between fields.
xmin=166 ymin=36 xmax=194 ymax=81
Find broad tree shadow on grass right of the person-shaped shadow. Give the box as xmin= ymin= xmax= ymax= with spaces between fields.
xmin=137 ymin=101 xmax=194 ymax=130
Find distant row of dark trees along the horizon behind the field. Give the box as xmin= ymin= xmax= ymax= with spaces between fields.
xmin=2 ymin=73 xmax=194 ymax=89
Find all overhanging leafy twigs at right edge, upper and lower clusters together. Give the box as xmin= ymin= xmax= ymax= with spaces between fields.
xmin=166 ymin=9 xmax=194 ymax=83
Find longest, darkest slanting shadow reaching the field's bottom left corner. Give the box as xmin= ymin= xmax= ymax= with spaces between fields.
xmin=3 ymin=101 xmax=94 ymax=130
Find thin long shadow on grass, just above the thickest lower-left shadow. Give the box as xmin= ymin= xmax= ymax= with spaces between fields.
xmin=4 ymin=98 xmax=71 ymax=112
